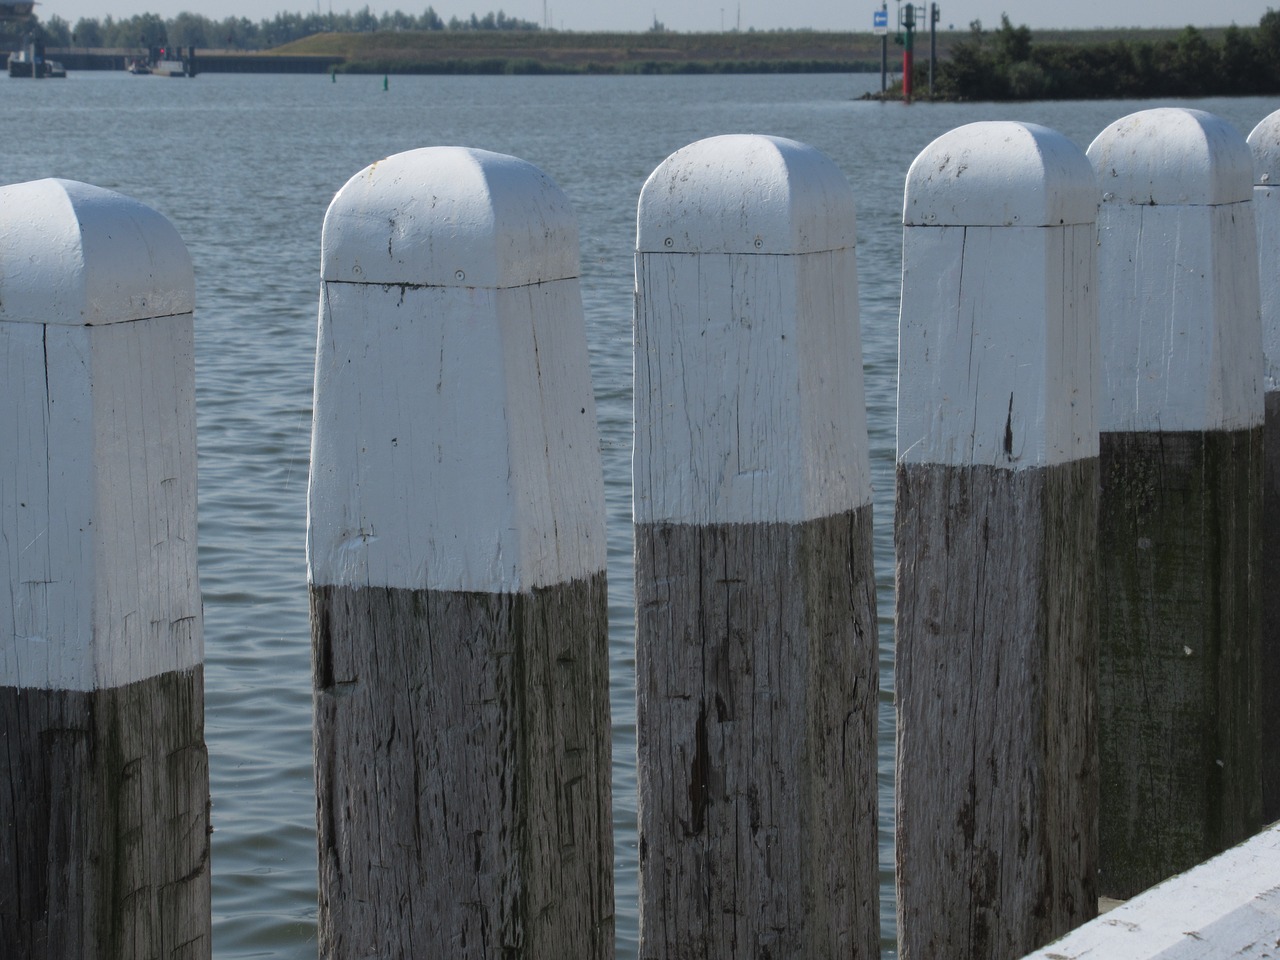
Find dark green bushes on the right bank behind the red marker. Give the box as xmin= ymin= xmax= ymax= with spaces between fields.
xmin=936 ymin=10 xmax=1280 ymax=100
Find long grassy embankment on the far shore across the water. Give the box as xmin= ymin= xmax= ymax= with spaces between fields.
xmin=269 ymin=28 xmax=1239 ymax=74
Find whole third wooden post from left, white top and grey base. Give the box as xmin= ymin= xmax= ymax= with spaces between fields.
xmin=634 ymin=137 xmax=879 ymax=960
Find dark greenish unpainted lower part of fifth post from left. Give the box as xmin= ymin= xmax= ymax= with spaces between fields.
xmin=1098 ymin=428 xmax=1262 ymax=899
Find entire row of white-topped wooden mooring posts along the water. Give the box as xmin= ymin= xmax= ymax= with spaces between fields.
xmin=0 ymin=109 xmax=1280 ymax=960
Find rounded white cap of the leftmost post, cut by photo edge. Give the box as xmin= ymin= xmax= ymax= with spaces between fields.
xmin=0 ymin=179 xmax=196 ymax=326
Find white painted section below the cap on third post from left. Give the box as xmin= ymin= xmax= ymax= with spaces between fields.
xmin=632 ymin=247 xmax=872 ymax=525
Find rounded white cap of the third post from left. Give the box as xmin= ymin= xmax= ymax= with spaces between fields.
xmin=636 ymin=134 xmax=858 ymax=255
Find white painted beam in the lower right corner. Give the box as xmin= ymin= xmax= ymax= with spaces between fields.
xmin=1025 ymin=824 xmax=1280 ymax=960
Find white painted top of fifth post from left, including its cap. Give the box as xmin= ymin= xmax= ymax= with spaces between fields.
xmin=1088 ymin=108 xmax=1263 ymax=433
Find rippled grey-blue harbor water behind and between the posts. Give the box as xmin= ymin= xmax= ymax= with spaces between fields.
xmin=0 ymin=65 xmax=1280 ymax=960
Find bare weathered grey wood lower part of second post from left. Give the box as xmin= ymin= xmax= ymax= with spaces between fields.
xmin=311 ymin=572 xmax=614 ymax=960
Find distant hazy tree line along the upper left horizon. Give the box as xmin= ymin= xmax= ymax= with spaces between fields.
xmin=31 ymin=6 xmax=540 ymax=50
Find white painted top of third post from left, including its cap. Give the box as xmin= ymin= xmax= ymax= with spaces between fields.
xmin=632 ymin=136 xmax=870 ymax=524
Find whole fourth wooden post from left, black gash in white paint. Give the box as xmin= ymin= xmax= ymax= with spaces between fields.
xmin=895 ymin=122 xmax=1098 ymax=960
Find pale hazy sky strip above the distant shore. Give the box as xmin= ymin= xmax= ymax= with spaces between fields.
xmin=36 ymin=0 xmax=1280 ymax=32
